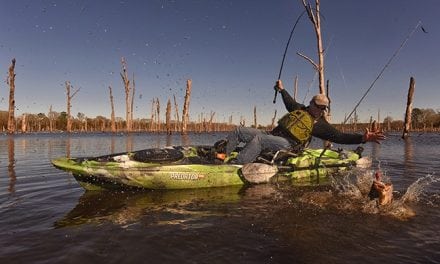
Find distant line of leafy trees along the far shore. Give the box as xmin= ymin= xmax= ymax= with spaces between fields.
xmin=0 ymin=108 xmax=440 ymax=133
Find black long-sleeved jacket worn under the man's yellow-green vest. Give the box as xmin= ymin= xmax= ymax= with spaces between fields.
xmin=271 ymin=90 xmax=365 ymax=144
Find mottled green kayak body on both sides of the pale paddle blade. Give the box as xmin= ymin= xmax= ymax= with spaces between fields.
xmin=52 ymin=146 xmax=368 ymax=190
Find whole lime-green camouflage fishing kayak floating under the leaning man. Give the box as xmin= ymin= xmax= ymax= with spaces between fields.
xmin=52 ymin=146 xmax=370 ymax=190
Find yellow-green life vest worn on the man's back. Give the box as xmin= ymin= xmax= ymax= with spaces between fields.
xmin=278 ymin=110 xmax=313 ymax=144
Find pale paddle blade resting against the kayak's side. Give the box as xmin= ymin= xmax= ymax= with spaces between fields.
xmin=241 ymin=163 xmax=278 ymax=183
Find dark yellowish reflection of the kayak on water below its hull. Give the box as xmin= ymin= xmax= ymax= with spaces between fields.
xmin=54 ymin=186 xmax=242 ymax=228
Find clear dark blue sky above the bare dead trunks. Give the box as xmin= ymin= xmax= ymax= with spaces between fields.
xmin=0 ymin=0 xmax=440 ymax=124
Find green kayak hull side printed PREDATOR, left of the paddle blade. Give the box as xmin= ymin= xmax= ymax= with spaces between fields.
xmin=52 ymin=158 xmax=244 ymax=190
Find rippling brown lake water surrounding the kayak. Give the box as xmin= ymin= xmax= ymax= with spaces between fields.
xmin=0 ymin=133 xmax=440 ymax=263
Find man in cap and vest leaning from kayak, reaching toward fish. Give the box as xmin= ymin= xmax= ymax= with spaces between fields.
xmin=216 ymin=80 xmax=385 ymax=164
